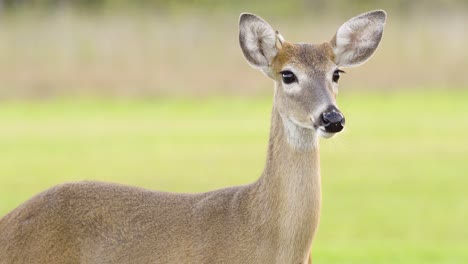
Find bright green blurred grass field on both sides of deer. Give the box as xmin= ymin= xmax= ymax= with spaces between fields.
xmin=0 ymin=92 xmax=468 ymax=264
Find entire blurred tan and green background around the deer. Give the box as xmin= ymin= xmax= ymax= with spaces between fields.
xmin=0 ymin=0 xmax=468 ymax=264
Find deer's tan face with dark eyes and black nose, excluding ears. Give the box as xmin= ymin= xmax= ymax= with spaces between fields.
xmin=272 ymin=42 xmax=344 ymax=137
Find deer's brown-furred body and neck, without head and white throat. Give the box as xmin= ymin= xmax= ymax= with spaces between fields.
xmin=0 ymin=105 xmax=320 ymax=264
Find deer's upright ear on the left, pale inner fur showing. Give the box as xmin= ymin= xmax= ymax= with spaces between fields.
xmin=239 ymin=13 xmax=278 ymax=77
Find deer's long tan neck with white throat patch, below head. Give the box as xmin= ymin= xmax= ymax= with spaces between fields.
xmin=252 ymin=104 xmax=321 ymax=258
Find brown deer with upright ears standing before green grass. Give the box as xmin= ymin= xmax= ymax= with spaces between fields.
xmin=0 ymin=10 xmax=387 ymax=264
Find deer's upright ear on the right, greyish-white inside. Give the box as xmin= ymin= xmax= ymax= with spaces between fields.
xmin=330 ymin=10 xmax=387 ymax=67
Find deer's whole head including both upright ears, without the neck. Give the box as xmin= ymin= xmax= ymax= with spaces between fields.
xmin=239 ymin=10 xmax=387 ymax=137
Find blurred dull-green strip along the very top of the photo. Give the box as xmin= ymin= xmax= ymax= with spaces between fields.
xmin=0 ymin=0 xmax=468 ymax=15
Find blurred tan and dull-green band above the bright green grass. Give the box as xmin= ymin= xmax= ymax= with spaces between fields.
xmin=0 ymin=0 xmax=468 ymax=99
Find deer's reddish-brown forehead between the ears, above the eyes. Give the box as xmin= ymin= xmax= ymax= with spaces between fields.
xmin=272 ymin=42 xmax=335 ymax=73
